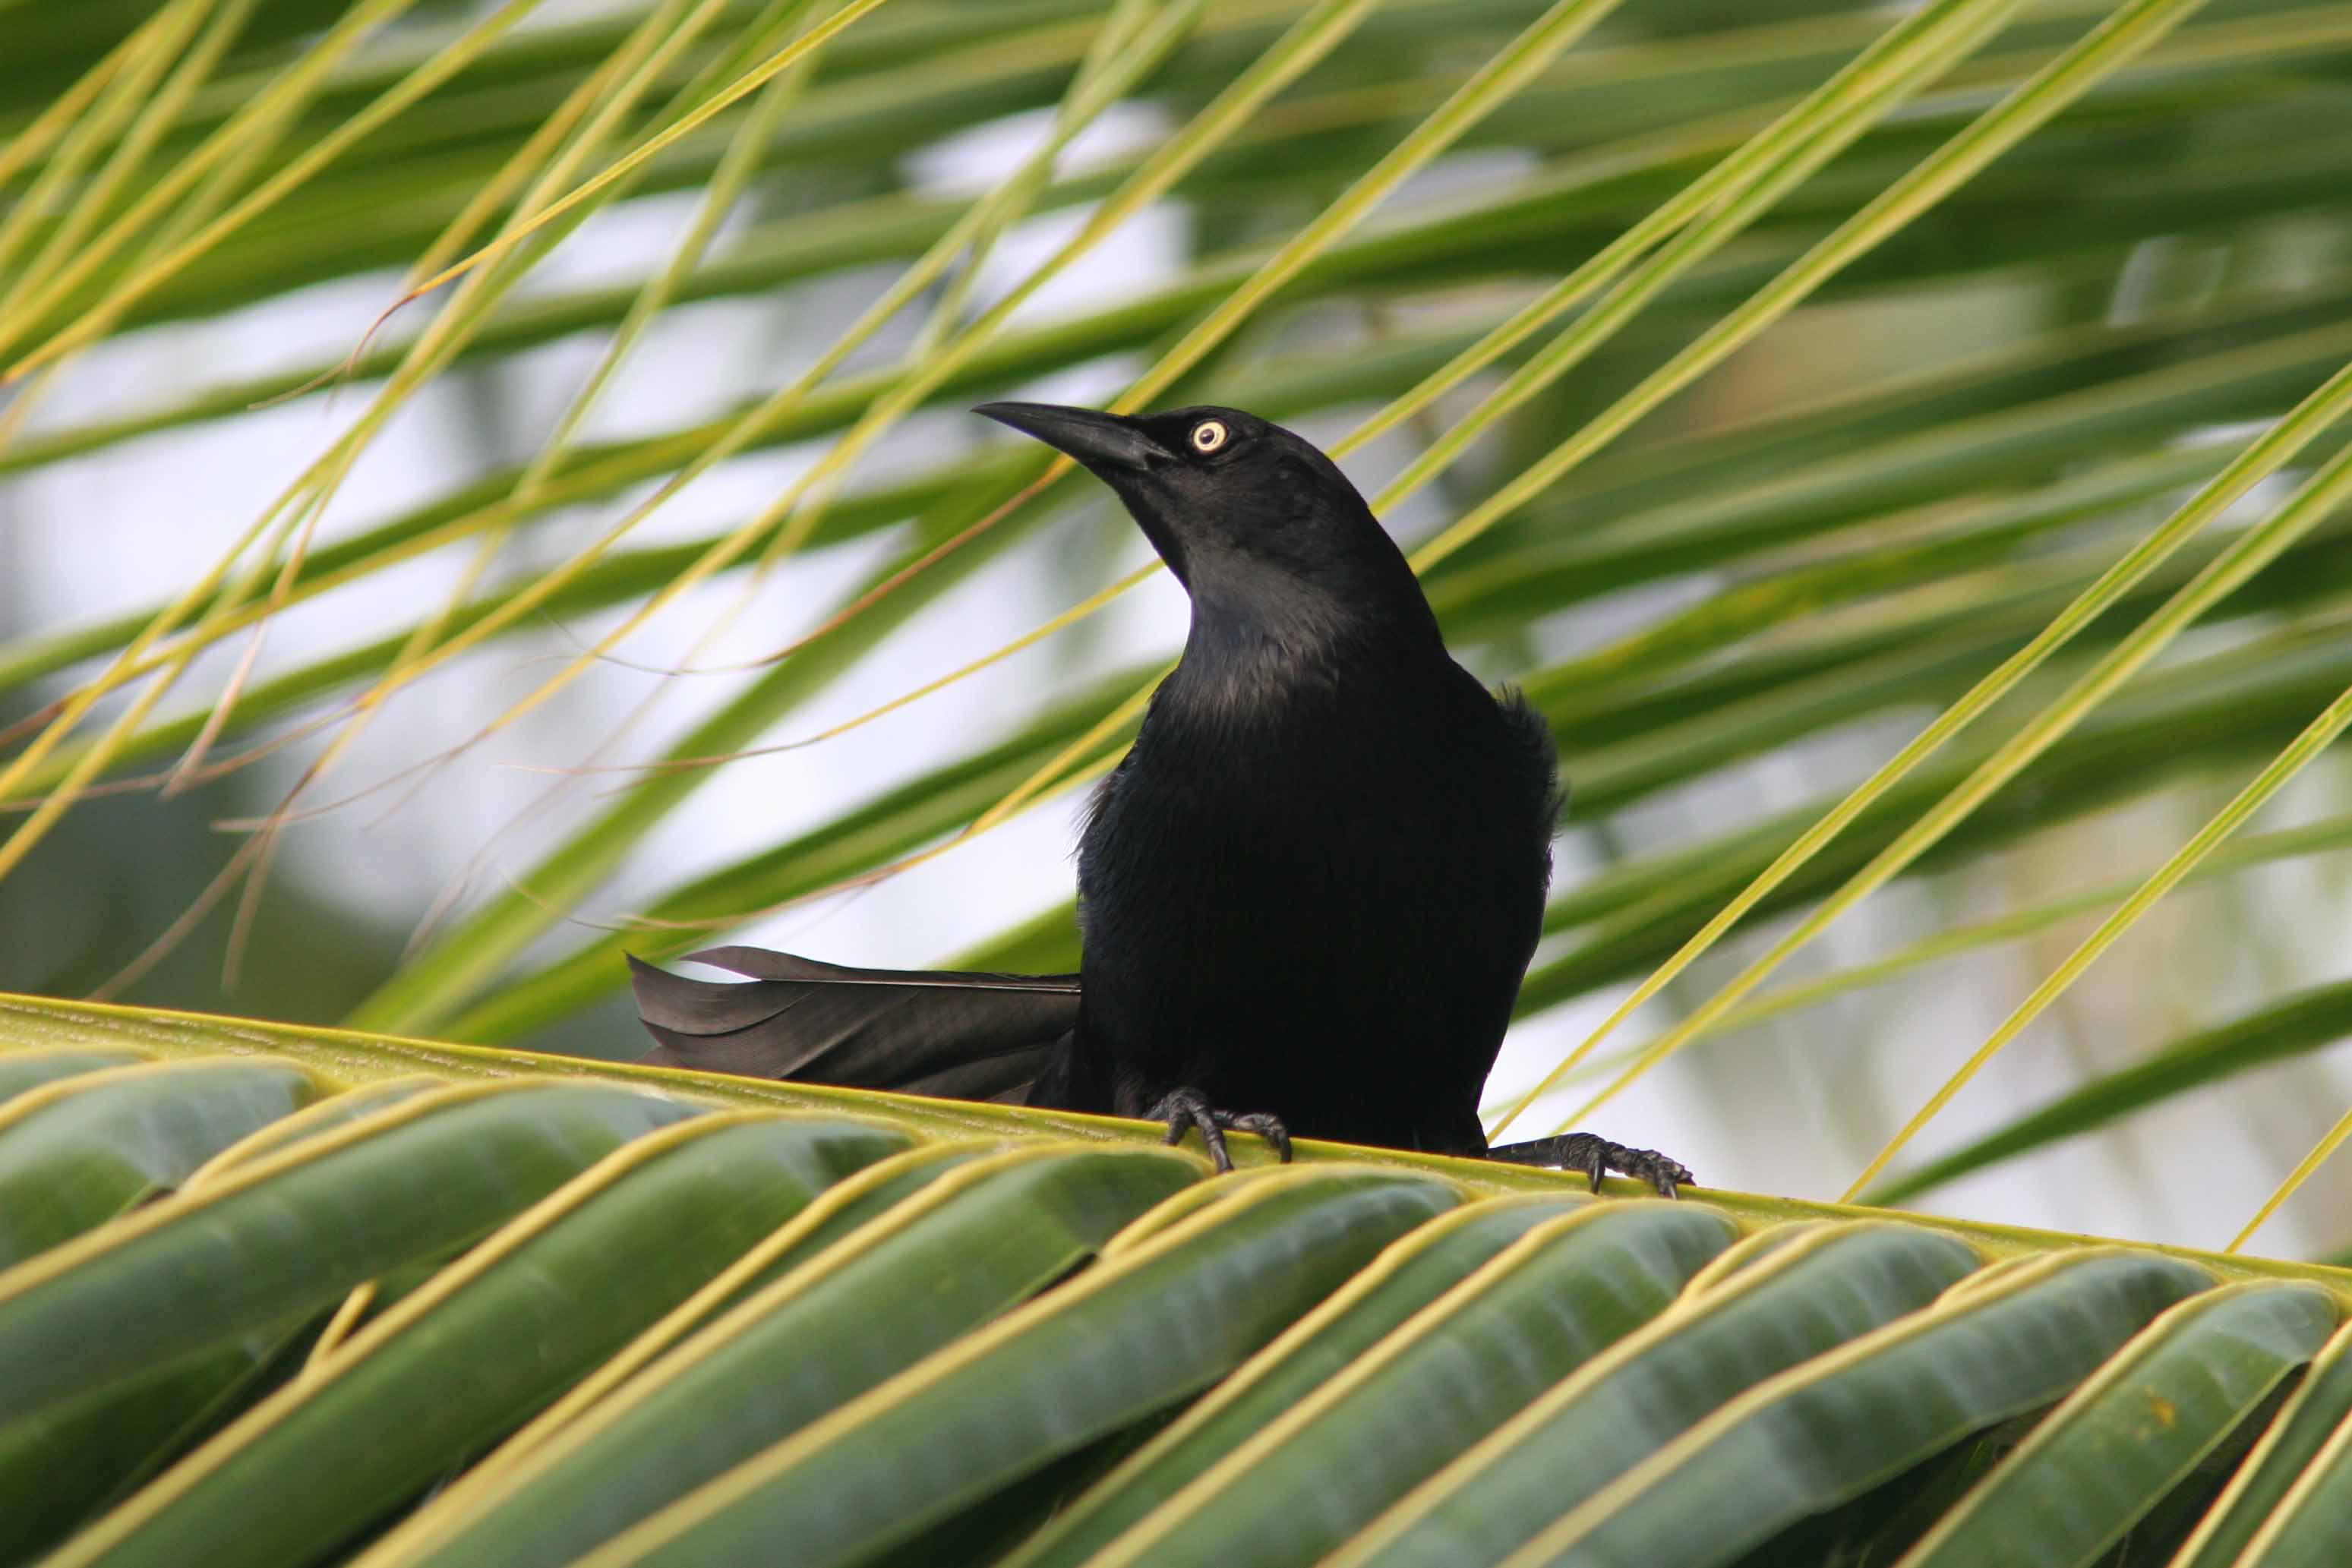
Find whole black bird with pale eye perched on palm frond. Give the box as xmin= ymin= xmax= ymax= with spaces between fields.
xmin=633 ymin=402 xmax=1691 ymax=1197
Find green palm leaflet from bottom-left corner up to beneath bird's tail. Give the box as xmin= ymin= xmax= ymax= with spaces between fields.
xmin=56 ymin=1112 xmax=905 ymax=1568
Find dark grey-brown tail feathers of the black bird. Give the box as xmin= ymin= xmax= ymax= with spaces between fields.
xmin=628 ymin=948 xmax=1077 ymax=1103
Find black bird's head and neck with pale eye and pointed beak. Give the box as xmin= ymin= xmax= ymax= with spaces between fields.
xmin=974 ymin=402 xmax=1435 ymax=635
